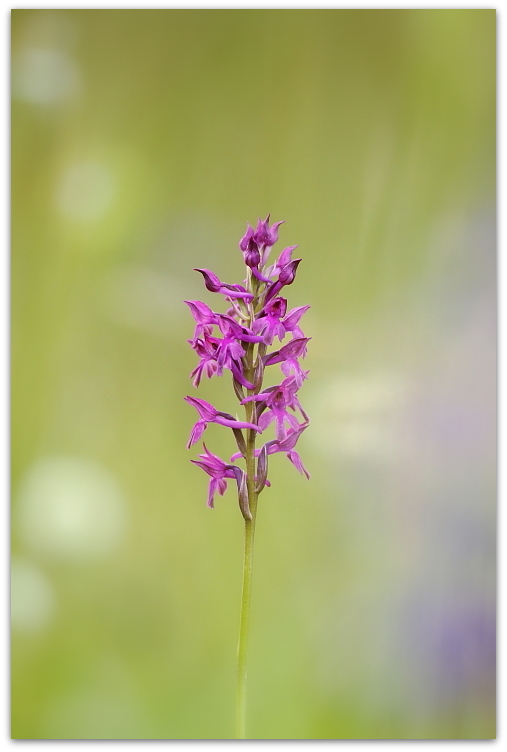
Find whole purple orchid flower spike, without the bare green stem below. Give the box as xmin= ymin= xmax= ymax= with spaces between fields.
xmin=185 ymin=214 xmax=310 ymax=520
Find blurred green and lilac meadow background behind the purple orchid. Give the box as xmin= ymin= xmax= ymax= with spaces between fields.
xmin=12 ymin=10 xmax=496 ymax=739
